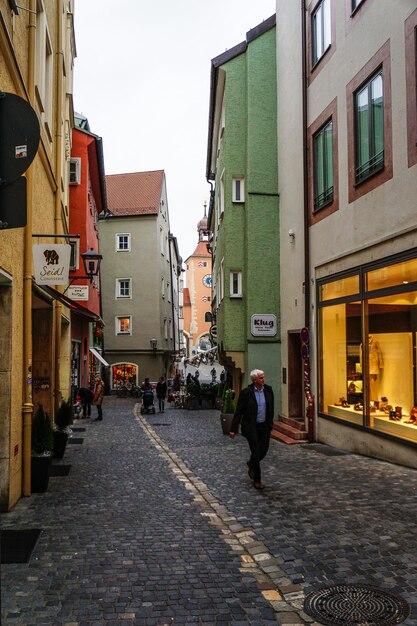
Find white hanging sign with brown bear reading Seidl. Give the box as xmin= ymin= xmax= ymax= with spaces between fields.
xmin=32 ymin=243 xmax=71 ymax=285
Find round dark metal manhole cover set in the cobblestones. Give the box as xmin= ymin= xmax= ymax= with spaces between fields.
xmin=304 ymin=585 xmax=410 ymax=626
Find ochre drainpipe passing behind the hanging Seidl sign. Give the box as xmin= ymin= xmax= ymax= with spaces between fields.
xmin=52 ymin=2 xmax=63 ymax=414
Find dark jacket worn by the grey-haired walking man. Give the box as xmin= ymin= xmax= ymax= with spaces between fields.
xmin=230 ymin=383 xmax=274 ymax=439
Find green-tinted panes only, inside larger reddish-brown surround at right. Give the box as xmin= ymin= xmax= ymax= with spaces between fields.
xmin=355 ymin=71 xmax=384 ymax=183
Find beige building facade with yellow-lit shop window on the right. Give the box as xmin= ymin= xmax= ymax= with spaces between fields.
xmin=277 ymin=0 xmax=417 ymax=467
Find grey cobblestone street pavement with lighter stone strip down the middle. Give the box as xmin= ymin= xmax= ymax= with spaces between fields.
xmin=0 ymin=397 xmax=417 ymax=626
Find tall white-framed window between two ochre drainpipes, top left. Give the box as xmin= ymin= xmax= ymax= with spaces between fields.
xmin=35 ymin=0 xmax=54 ymax=141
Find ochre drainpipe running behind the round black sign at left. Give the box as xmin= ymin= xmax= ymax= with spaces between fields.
xmin=22 ymin=0 xmax=36 ymax=496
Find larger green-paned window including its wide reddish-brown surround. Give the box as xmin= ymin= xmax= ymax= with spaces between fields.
xmin=346 ymin=40 xmax=393 ymax=202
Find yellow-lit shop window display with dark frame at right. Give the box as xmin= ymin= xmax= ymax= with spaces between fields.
xmin=317 ymin=250 xmax=417 ymax=447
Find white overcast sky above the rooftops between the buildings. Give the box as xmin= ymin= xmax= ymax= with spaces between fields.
xmin=74 ymin=0 xmax=278 ymax=259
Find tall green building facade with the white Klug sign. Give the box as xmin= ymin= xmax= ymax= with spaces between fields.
xmin=207 ymin=16 xmax=281 ymax=407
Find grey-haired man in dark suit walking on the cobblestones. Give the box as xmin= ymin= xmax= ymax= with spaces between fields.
xmin=230 ymin=369 xmax=274 ymax=489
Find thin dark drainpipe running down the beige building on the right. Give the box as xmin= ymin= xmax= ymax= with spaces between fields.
xmin=301 ymin=0 xmax=315 ymax=441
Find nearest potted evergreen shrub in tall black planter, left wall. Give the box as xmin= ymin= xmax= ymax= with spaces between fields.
xmin=31 ymin=404 xmax=53 ymax=493
